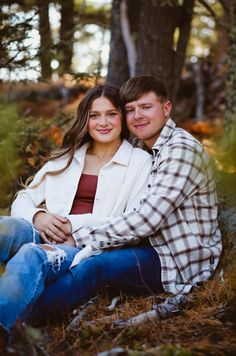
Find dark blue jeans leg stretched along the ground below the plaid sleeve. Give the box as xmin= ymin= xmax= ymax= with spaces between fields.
xmin=33 ymin=246 xmax=162 ymax=321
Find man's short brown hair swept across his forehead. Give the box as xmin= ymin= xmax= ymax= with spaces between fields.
xmin=120 ymin=74 xmax=168 ymax=105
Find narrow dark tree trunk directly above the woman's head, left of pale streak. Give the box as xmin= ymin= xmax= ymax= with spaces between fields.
xmin=106 ymin=0 xmax=129 ymax=87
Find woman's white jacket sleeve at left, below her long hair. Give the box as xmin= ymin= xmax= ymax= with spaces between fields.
xmin=11 ymin=163 xmax=49 ymax=223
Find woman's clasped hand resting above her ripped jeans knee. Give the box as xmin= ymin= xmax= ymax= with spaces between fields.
xmin=33 ymin=211 xmax=71 ymax=243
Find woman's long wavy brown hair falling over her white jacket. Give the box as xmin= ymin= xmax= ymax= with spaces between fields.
xmin=26 ymin=85 xmax=129 ymax=188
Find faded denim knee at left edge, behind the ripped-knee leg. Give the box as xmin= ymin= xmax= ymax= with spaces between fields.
xmin=0 ymin=216 xmax=41 ymax=263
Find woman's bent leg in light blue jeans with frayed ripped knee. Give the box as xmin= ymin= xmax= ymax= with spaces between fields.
xmin=0 ymin=243 xmax=78 ymax=331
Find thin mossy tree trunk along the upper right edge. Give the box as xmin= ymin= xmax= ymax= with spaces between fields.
xmin=225 ymin=0 xmax=236 ymax=132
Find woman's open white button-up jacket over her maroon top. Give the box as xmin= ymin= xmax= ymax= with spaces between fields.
xmin=11 ymin=140 xmax=151 ymax=231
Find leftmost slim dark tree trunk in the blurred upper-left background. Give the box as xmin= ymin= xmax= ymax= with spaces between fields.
xmin=37 ymin=0 xmax=52 ymax=79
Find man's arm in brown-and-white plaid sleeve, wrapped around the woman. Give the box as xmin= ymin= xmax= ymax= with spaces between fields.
xmin=76 ymin=145 xmax=205 ymax=249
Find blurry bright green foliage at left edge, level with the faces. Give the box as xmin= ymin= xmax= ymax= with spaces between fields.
xmin=0 ymin=104 xmax=22 ymax=208
